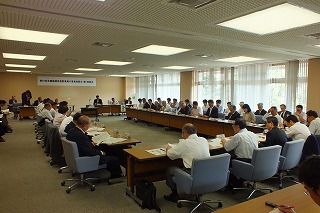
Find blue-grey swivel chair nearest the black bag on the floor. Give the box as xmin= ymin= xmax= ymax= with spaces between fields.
xmin=173 ymin=153 xmax=230 ymax=213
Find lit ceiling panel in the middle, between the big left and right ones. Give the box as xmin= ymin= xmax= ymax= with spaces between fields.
xmin=132 ymin=44 xmax=191 ymax=56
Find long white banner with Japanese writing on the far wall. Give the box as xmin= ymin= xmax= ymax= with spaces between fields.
xmin=38 ymin=76 xmax=96 ymax=87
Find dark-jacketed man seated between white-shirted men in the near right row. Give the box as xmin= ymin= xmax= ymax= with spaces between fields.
xmin=259 ymin=116 xmax=288 ymax=147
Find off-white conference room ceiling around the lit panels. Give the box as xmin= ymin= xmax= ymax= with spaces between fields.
xmin=0 ymin=0 xmax=320 ymax=76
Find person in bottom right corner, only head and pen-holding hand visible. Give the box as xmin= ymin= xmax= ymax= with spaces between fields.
xmin=278 ymin=155 xmax=320 ymax=213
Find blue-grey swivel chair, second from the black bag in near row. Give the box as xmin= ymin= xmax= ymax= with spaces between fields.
xmin=230 ymin=145 xmax=281 ymax=200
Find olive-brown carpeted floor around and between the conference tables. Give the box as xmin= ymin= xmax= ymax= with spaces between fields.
xmin=0 ymin=116 xmax=292 ymax=213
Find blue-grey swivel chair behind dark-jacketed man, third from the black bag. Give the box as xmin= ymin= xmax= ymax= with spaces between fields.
xmin=278 ymin=139 xmax=304 ymax=189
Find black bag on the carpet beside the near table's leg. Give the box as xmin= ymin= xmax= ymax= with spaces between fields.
xmin=136 ymin=179 xmax=161 ymax=212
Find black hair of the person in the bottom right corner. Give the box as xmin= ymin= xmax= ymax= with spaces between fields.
xmin=298 ymin=155 xmax=320 ymax=191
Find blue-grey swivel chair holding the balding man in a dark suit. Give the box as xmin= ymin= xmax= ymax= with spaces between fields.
xmin=61 ymin=138 xmax=110 ymax=194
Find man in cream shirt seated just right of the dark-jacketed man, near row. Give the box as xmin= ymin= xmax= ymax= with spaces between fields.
xmin=285 ymin=115 xmax=311 ymax=140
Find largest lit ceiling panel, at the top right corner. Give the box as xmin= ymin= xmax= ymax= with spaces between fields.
xmin=218 ymin=3 xmax=320 ymax=35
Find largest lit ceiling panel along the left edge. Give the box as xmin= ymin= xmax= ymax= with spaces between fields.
xmin=0 ymin=27 xmax=68 ymax=45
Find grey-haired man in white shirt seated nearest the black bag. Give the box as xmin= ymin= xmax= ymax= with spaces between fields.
xmin=164 ymin=123 xmax=210 ymax=203
